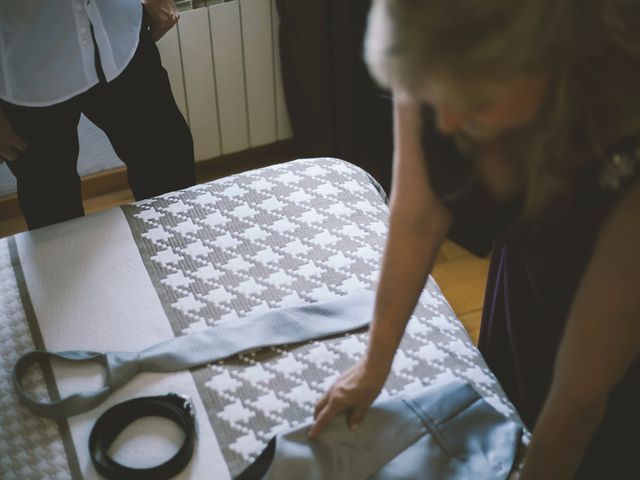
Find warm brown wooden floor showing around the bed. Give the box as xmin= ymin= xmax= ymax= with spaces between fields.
xmin=0 ymin=186 xmax=489 ymax=344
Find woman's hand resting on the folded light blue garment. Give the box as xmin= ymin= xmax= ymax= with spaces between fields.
xmin=309 ymin=359 xmax=389 ymax=438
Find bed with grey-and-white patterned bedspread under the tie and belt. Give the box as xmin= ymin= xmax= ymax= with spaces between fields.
xmin=0 ymin=158 xmax=519 ymax=480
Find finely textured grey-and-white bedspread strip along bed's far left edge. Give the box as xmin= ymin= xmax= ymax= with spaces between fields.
xmin=0 ymin=239 xmax=71 ymax=480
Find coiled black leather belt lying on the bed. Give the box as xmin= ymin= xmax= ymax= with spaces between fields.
xmin=89 ymin=393 xmax=196 ymax=480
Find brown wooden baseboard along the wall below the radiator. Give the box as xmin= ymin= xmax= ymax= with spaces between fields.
xmin=0 ymin=140 xmax=296 ymax=221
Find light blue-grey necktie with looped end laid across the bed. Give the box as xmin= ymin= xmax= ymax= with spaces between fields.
xmin=13 ymin=290 xmax=375 ymax=419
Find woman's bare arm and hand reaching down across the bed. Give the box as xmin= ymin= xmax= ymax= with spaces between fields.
xmin=309 ymin=95 xmax=451 ymax=437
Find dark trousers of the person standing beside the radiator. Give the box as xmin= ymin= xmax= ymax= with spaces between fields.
xmin=2 ymin=9 xmax=195 ymax=229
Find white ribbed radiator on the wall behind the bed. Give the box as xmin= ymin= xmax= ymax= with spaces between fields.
xmin=158 ymin=0 xmax=292 ymax=161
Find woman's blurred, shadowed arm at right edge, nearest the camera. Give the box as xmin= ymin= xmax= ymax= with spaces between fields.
xmin=521 ymin=184 xmax=640 ymax=480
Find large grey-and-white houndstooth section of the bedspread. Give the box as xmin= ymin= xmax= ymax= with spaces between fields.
xmin=123 ymin=159 xmax=517 ymax=475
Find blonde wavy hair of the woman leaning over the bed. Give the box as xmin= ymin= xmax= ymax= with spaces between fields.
xmin=365 ymin=0 xmax=640 ymax=217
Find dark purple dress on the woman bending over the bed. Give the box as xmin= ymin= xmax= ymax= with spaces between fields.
xmin=422 ymin=109 xmax=640 ymax=479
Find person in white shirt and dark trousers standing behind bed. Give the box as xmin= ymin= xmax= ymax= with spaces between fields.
xmin=0 ymin=0 xmax=195 ymax=229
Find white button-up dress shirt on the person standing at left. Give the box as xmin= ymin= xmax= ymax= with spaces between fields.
xmin=0 ymin=0 xmax=142 ymax=107
